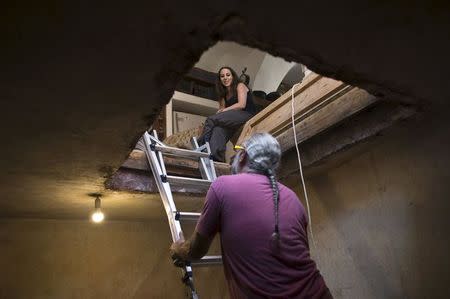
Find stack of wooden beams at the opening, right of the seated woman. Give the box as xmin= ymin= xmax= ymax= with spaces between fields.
xmin=238 ymin=73 xmax=377 ymax=152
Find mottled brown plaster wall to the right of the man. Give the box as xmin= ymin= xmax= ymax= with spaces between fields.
xmin=284 ymin=114 xmax=450 ymax=298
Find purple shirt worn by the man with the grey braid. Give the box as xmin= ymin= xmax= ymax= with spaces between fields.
xmin=197 ymin=173 xmax=327 ymax=298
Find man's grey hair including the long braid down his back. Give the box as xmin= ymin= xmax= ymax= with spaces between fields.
xmin=242 ymin=133 xmax=281 ymax=244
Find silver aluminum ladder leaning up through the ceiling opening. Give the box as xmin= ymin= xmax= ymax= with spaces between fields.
xmin=143 ymin=130 xmax=222 ymax=299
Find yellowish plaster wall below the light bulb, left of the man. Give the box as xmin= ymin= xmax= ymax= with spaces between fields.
xmin=0 ymin=219 xmax=227 ymax=299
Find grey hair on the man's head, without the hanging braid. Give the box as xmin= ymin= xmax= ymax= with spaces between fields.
xmin=242 ymin=133 xmax=281 ymax=174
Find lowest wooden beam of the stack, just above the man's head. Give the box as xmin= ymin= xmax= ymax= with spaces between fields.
xmin=275 ymin=88 xmax=376 ymax=152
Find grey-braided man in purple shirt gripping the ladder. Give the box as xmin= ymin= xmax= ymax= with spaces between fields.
xmin=171 ymin=134 xmax=332 ymax=299
